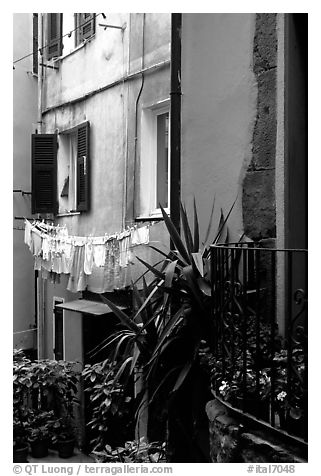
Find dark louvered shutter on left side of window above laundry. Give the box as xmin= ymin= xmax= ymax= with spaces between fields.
xmin=31 ymin=134 xmax=57 ymax=213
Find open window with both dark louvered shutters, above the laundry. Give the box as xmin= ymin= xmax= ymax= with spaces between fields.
xmin=32 ymin=122 xmax=90 ymax=213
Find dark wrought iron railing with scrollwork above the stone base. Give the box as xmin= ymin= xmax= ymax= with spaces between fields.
xmin=211 ymin=243 xmax=308 ymax=441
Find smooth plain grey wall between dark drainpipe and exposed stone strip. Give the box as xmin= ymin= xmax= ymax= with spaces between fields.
xmin=181 ymin=13 xmax=257 ymax=244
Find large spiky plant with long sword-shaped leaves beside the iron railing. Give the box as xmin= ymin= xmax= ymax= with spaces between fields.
xmin=88 ymin=196 xmax=236 ymax=450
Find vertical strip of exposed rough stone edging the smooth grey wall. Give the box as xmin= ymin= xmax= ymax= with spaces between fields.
xmin=242 ymin=13 xmax=277 ymax=239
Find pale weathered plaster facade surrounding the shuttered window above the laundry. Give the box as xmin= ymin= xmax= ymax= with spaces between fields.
xmin=39 ymin=14 xmax=170 ymax=359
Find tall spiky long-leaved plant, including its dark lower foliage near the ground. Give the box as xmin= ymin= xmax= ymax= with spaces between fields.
xmin=85 ymin=200 xmax=236 ymax=461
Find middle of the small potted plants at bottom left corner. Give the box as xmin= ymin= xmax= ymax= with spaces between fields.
xmin=28 ymin=410 xmax=57 ymax=458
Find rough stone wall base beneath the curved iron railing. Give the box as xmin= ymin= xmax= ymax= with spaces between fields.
xmin=206 ymin=399 xmax=307 ymax=463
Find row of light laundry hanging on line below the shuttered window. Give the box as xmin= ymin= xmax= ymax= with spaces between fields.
xmin=24 ymin=219 xmax=151 ymax=292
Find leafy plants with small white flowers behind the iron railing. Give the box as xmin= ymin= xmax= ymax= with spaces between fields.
xmin=202 ymin=315 xmax=305 ymax=426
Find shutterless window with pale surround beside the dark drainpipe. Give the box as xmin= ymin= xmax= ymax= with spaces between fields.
xmin=140 ymin=101 xmax=170 ymax=216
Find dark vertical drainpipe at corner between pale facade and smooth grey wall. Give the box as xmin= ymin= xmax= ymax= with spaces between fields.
xmin=170 ymin=13 xmax=182 ymax=244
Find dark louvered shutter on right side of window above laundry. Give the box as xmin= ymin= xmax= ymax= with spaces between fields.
xmin=77 ymin=122 xmax=90 ymax=211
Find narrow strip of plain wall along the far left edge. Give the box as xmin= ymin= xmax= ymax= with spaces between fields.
xmin=13 ymin=13 xmax=37 ymax=348
